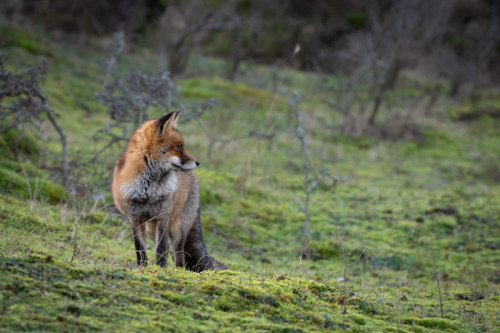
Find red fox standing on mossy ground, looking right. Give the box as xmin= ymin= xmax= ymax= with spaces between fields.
xmin=111 ymin=110 xmax=227 ymax=272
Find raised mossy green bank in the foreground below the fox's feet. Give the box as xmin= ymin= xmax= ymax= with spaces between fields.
xmin=0 ymin=252 xmax=472 ymax=332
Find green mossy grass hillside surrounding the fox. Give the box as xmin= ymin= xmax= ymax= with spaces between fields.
xmin=0 ymin=26 xmax=500 ymax=332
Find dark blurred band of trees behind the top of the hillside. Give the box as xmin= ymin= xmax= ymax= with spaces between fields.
xmin=0 ymin=0 xmax=500 ymax=89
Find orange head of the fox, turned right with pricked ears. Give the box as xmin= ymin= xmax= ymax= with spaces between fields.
xmin=143 ymin=110 xmax=200 ymax=171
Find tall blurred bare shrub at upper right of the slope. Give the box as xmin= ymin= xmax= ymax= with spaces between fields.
xmin=340 ymin=0 xmax=454 ymax=133
